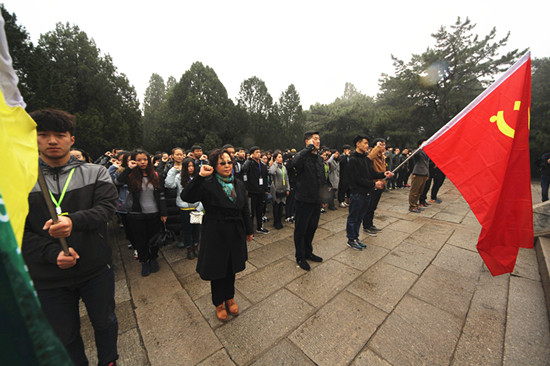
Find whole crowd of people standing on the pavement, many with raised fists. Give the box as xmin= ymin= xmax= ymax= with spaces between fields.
xmin=23 ymin=110 xmax=452 ymax=365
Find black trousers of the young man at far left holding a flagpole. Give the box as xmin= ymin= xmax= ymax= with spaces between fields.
xmin=36 ymin=267 xmax=118 ymax=366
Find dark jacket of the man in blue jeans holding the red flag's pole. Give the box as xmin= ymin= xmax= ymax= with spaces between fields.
xmin=352 ymin=151 xmax=384 ymax=195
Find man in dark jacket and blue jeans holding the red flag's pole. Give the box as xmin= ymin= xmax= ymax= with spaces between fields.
xmin=346 ymin=135 xmax=393 ymax=250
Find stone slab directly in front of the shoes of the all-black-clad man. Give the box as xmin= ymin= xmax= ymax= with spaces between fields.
xmin=286 ymin=259 xmax=361 ymax=307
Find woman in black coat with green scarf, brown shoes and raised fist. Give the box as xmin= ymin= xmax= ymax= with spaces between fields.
xmin=181 ymin=149 xmax=253 ymax=321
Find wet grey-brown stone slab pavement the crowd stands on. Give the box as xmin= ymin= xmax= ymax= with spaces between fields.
xmin=82 ymin=180 xmax=550 ymax=366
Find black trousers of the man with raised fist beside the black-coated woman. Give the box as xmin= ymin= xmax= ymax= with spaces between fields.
xmin=294 ymin=200 xmax=321 ymax=260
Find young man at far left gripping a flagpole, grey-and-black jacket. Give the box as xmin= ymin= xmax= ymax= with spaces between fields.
xmin=22 ymin=109 xmax=118 ymax=366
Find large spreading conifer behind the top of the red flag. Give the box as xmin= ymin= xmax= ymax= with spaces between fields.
xmin=378 ymin=18 xmax=521 ymax=142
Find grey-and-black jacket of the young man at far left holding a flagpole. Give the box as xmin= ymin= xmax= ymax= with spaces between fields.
xmin=22 ymin=158 xmax=118 ymax=290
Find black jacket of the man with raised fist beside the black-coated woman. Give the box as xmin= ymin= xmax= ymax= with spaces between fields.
xmin=289 ymin=144 xmax=328 ymax=203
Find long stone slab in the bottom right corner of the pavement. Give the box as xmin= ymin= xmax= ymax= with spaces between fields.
xmin=503 ymin=276 xmax=550 ymax=366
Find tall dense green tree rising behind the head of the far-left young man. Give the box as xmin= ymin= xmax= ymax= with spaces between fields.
xmin=33 ymin=23 xmax=142 ymax=155
